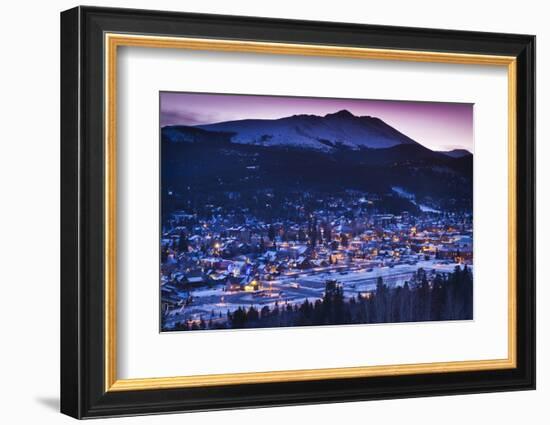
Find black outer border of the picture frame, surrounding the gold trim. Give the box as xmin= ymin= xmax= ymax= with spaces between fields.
xmin=61 ymin=7 xmax=535 ymax=418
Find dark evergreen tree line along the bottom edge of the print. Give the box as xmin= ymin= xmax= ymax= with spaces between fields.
xmin=175 ymin=266 xmax=473 ymax=330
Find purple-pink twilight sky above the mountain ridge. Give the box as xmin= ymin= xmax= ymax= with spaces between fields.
xmin=160 ymin=92 xmax=474 ymax=152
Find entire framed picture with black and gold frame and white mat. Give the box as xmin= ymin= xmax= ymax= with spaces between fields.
xmin=61 ymin=7 xmax=535 ymax=418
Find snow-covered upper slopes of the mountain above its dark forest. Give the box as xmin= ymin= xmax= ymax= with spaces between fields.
xmin=163 ymin=110 xmax=418 ymax=152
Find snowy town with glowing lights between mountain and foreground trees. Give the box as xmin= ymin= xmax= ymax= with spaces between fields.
xmin=160 ymin=188 xmax=473 ymax=331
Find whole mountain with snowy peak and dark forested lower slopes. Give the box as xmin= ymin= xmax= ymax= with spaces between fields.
xmin=161 ymin=110 xmax=473 ymax=211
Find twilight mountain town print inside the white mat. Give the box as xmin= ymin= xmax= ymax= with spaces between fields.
xmin=159 ymin=91 xmax=474 ymax=332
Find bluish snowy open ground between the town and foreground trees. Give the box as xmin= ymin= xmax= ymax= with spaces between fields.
xmin=165 ymin=260 xmax=470 ymax=327
